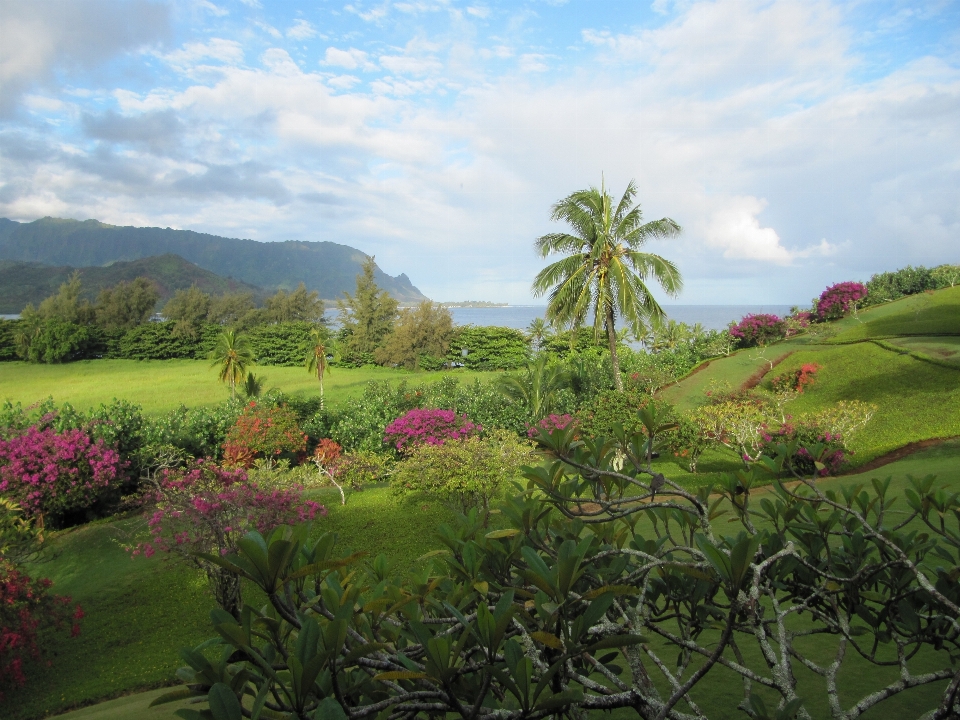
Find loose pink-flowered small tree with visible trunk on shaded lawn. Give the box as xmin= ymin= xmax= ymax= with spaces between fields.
xmin=130 ymin=460 xmax=326 ymax=617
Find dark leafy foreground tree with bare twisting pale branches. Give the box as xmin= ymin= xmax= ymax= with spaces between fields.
xmin=158 ymin=426 xmax=960 ymax=720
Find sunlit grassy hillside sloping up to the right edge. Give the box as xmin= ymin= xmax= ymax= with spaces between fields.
xmin=661 ymin=287 xmax=960 ymax=472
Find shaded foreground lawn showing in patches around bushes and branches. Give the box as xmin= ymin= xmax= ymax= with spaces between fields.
xmin=13 ymin=441 xmax=960 ymax=720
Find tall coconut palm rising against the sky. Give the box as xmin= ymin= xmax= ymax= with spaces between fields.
xmin=533 ymin=180 xmax=683 ymax=390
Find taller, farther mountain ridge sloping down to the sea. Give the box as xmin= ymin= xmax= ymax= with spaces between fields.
xmin=0 ymin=217 xmax=427 ymax=303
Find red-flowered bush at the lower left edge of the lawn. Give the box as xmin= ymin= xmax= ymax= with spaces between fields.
xmin=0 ymin=558 xmax=83 ymax=700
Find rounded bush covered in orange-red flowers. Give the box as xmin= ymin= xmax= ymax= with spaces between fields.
xmin=223 ymin=402 xmax=307 ymax=468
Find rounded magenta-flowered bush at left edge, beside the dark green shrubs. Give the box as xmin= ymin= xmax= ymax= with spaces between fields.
xmin=0 ymin=425 xmax=122 ymax=524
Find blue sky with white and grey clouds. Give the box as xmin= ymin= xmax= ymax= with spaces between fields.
xmin=0 ymin=0 xmax=960 ymax=305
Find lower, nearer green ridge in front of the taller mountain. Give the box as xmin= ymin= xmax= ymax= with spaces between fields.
xmin=0 ymin=254 xmax=269 ymax=314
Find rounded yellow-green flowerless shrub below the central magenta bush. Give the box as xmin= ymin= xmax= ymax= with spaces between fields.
xmin=391 ymin=430 xmax=535 ymax=512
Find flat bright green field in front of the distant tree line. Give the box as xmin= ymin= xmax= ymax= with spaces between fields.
xmin=0 ymin=360 xmax=491 ymax=414
